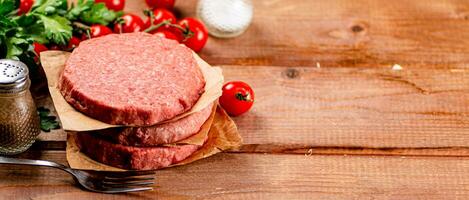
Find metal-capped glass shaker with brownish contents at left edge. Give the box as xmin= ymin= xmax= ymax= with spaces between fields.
xmin=0 ymin=59 xmax=41 ymax=155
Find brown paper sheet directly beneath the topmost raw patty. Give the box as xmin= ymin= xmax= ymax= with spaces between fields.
xmin=41 ymin=51 xmax=224 ymax=131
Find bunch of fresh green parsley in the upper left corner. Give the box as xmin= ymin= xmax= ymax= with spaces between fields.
xmin=0 ymin=0 xmax=122 ymax=74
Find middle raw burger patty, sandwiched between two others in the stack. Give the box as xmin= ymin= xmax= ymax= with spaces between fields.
xmin=100 ymin=104 xmax=213 ymax=146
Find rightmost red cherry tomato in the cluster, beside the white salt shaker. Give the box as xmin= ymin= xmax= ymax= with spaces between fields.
xmin=178 ymin=17 xmax=208 ymax=52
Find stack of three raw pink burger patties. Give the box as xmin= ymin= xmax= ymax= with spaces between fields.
xmin=59 ymin=33 xmax=212 ymax=170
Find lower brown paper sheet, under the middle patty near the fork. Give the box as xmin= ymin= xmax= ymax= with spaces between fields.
xmin=66 ymin=107 xmax=242 ymax=171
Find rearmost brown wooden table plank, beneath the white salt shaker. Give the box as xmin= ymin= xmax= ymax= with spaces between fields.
xmin=126 ymin=0 xmax=469 ymax=68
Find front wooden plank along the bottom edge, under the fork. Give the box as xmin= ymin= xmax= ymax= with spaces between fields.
xmin=0 ymin=151 xmax=469 ymax=200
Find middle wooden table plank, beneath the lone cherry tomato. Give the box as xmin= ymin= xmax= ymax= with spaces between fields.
xmin=34 ymin=66 xmax=469 ymax=149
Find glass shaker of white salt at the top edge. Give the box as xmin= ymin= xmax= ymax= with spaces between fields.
xmin=197 ymin=0 xmax=253 ymax=38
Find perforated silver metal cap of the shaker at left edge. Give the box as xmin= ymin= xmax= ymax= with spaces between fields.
xmin=0 ymin=59 xmax=30 ymax=93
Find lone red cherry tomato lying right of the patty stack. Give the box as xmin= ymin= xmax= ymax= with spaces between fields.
xmin=219 ymin=81 xmax=254 ymax=116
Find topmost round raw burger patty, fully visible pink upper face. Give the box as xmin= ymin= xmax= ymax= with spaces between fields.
xmin=59 ymin=32 xmax=205 ymax=126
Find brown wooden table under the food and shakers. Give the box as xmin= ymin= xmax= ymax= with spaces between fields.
xmin=5 ymin=0 xmax=469 ymax=200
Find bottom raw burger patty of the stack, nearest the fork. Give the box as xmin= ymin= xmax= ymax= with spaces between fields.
xmin=76 ymin=133 xmax=199 ymax=170
